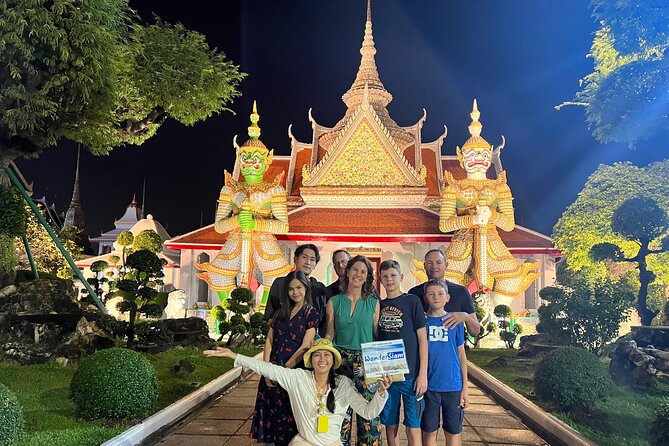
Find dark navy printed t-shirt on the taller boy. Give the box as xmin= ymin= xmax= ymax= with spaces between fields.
xmin=378 ymin=293 xmax=426 ymax=379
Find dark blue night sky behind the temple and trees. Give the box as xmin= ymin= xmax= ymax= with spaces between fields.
xmin=13 ymin=0 xmax=669 ymax=242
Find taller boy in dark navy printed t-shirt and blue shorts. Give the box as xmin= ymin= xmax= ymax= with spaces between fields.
xmin=377 ymin=260 xmax=427 ymax=446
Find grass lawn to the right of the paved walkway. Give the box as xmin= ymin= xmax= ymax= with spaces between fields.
xmin=467 ymin=349 xmax=669 ymax=446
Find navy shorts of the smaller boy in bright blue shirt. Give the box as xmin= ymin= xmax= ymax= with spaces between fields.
xmin=420 ymin=390 xmax=465 ymax=435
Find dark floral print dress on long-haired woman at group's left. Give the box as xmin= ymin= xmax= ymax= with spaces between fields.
xmin=251 ymin=305 xmax=320 ymax=446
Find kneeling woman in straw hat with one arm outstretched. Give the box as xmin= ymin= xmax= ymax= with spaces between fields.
xmin=204 ymin=339 xmax=392 ymax=446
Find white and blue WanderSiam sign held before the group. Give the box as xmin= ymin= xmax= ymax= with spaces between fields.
xmin=361 ymin=339 xmax=409 ymax=382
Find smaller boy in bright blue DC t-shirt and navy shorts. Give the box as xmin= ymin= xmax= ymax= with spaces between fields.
xmin=421 ymin=279 xmax=469 ymax=446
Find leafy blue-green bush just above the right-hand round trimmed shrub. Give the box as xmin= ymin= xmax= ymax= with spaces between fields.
xmin=537 ymin=273 xmax=634 ymax=353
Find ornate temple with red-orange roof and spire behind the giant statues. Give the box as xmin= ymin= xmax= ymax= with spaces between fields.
xmin=165 ymin=3 xmax=559 ymax=312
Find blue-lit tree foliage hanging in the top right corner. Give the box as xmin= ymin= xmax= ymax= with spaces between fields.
xmin=557 ymin=0 xmax=669 ymax=144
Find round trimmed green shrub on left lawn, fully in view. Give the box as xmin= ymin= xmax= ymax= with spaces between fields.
xmin=70 ymin=348 xmax=158 ymax=419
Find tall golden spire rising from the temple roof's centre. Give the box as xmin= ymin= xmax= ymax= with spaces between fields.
xmin=342 ymin=0 xmax=393 ymax=108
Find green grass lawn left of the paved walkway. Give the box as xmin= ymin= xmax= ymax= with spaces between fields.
xmin=0 ymin=348 xmax=259 ymax=446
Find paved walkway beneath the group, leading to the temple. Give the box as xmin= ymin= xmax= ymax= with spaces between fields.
xmin=156 ymin=375 xmax=548 ymax=446
